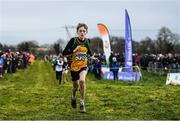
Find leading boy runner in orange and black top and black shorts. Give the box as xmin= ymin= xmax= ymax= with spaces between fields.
xmin=63 ymin=23 xmax=95 ymax=113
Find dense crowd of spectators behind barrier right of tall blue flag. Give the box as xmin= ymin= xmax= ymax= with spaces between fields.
xmin=134 ymin=53 xmax=180 ymax=73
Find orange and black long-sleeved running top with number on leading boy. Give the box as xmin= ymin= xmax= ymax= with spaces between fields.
xmin=63 ymin=37 xmax=92 ymax=71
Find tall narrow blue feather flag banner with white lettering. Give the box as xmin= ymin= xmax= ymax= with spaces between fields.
xmin=125 ymin=10 xmax=133 ymax=72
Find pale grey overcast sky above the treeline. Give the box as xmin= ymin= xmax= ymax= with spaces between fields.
xmin=0 ymin=0 xmax=180 ymax=44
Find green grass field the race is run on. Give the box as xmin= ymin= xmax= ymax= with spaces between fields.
xmin=0 ymin=61 xmax=180 ymax=120
